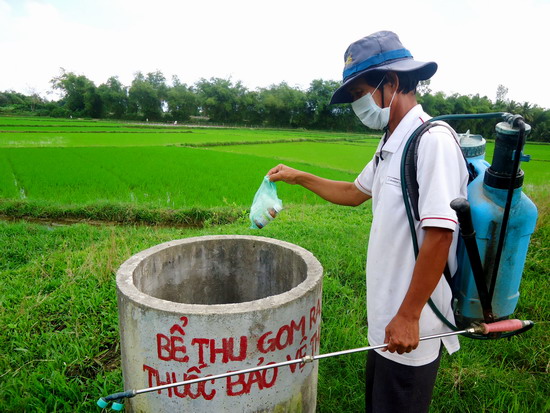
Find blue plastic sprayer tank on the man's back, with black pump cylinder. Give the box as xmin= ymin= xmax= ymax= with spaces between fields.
xmin=453 ymin=122 xmax=537 ymax=325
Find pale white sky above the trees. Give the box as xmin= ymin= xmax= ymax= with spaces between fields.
xmin=0 ymin=0 xmax=550 ymax=108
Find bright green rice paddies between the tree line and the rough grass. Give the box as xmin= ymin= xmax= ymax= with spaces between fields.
xmin=0 ymin=118 xmax=550 ymax=208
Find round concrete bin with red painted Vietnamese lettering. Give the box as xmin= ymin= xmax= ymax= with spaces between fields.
xmin=117 ymin=235 xmax=323 ymax=413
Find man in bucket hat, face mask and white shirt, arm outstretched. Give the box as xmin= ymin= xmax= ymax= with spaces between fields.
xmin=268 ymin=32 xmax=468 ymax=412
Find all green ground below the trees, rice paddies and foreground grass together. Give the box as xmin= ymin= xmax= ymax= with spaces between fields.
xmin=0 ymin=117 xmax=550 ymax=413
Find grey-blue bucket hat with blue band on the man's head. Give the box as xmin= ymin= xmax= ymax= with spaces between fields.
xmin=330 ymin=31 xmax=437 ymax=104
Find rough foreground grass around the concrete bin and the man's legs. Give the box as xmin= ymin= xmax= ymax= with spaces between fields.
xmin=0 ymin=201 xmax=550 ymax=412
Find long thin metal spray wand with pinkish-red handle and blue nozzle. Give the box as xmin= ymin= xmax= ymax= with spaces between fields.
xmin=97 ymin=319 xmax=534 ymax=411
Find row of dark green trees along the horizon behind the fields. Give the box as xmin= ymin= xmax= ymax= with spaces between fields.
xmin=0 ymin=69 xmax=550 ymax=142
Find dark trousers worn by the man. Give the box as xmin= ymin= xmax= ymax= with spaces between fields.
xmin=365 ymin=350 xmax=441 ymax=413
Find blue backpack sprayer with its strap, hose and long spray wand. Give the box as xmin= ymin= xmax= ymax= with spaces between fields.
xmin=97 ymin=113 xmax=537 ymax=411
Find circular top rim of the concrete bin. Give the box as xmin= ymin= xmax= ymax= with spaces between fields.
xmin=116 ymin=235 xmax=323 ymax=315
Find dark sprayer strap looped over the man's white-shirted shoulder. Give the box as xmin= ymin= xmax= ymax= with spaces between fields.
xmin=403 ymin=122 xmax=475 ymax=221
